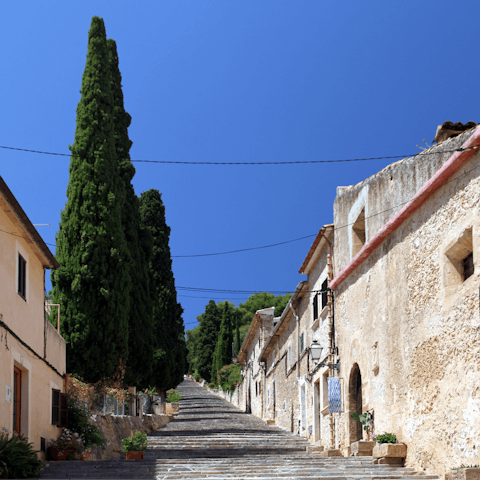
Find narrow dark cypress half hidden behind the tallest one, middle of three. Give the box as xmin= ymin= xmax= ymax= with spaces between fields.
xmin=107 ymin=39 xmax=154 ymax=388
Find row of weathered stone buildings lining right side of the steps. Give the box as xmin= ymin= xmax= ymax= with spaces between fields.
xmin=227 ymin=122 xmax=480 ymax=473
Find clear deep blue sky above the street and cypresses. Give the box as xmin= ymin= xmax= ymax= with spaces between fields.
xmin=0 ymin=0 xmax=480 ymax=329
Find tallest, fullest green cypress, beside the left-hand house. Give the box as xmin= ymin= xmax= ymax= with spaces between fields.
xmin=52 ymin=17 xmax=131 ymax=382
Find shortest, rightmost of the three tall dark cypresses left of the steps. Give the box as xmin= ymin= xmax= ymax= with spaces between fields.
xmin=140 ymin=189 xmax=187 ymax=390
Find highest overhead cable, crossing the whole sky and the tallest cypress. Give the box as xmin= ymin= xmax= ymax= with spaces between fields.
xmin=0 ymin=145 xmax=478 ymax=165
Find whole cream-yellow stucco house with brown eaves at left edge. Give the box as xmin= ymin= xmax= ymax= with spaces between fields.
xmin=0 ymin=177 xmax=66 ymax=456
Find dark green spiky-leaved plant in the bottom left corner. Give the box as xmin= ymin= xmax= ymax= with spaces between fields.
xmin=0 ymin=431 xmax=44 ymax=478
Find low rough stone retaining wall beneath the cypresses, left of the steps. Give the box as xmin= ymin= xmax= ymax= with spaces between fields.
xmin=89 ymin=415 xmax=173 ymax=460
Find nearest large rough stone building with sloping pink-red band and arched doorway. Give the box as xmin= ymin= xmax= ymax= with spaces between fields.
xmin=330 ymin=127 xmax=480 ymax=473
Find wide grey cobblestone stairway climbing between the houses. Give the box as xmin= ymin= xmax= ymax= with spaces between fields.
xmin=42 ymin=380 xmax=438 ymax=480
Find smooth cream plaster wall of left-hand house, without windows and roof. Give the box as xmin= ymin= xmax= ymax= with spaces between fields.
xmin=0 ymin=208 xmax=66 ymax=458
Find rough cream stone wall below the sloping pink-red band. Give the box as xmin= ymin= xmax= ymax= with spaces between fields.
xmin=335 ymin=145 xmax=480 ymax=473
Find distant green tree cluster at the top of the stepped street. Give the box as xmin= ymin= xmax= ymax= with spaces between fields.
xmin=186 ymin=292 xmax=291 ymax=382
